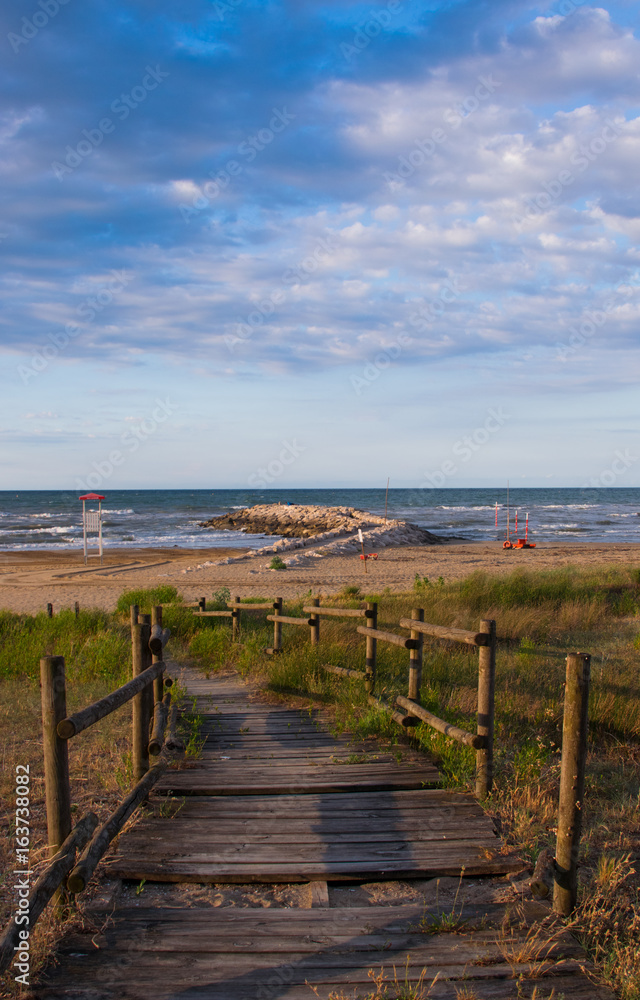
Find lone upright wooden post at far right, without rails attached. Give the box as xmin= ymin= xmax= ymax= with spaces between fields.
xmin=553 ymin=653 xmax=591 ymax=917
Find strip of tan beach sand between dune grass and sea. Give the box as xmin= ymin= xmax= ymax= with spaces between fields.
xmin=0 ymin=542 xmax=640 ymax=614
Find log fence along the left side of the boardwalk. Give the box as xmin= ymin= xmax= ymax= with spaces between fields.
xmin=0 ymin=605 xmax=184 ymax=972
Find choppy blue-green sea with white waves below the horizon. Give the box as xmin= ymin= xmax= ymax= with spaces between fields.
xmin=0 ymin=487 xmax=640 ymax=550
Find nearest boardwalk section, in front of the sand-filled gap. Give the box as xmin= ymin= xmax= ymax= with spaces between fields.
xmin=36 ymin=904 xmax=613 ymax=1000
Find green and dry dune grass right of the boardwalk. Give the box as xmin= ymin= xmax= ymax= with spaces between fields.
xmin=181 ymin=567 xmax=640 ymax=1000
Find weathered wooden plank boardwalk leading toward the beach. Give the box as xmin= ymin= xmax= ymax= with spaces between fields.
xmin=34 ymin=675 xmax=612 ymax=1000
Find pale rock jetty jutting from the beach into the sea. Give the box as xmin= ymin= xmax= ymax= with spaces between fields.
xmin=200 ymin=504 xmax=444 ymax=566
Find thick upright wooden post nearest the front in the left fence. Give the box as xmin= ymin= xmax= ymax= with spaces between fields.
xmin=40 ymin=656 xmax=71 ymax=858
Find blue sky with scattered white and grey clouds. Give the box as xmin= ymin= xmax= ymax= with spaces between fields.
xmin=0 ymin=0 xmax=640 ymax=492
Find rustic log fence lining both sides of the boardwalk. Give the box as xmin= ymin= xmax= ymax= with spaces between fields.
xmin=0 ymin=597 xmax=591 ymax=972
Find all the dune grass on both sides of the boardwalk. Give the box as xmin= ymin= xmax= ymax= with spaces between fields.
xmin=0 ymin=567 xmax=640 ymax=1000
